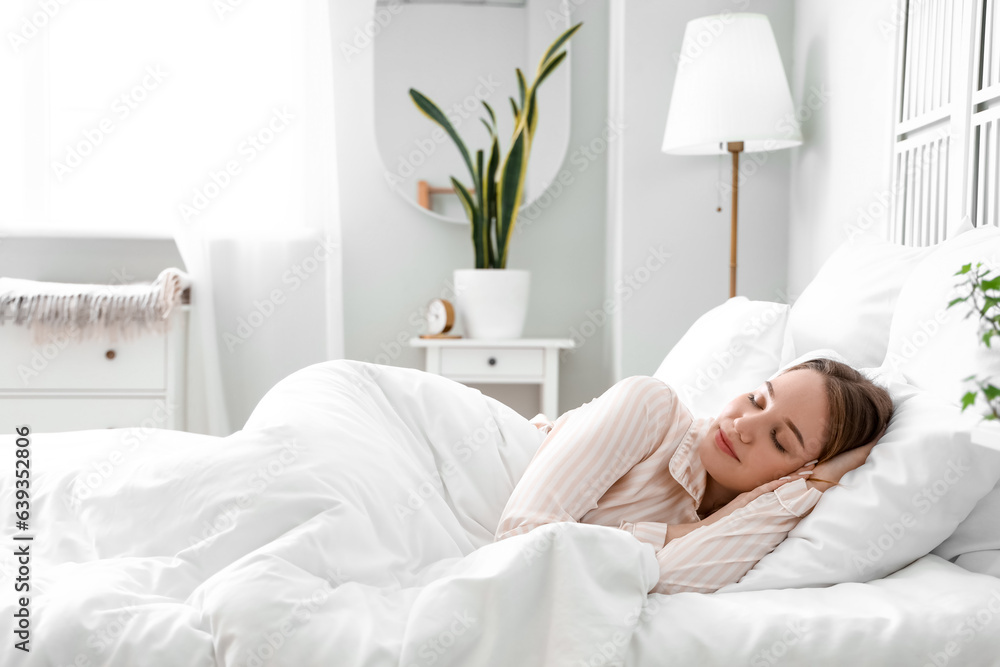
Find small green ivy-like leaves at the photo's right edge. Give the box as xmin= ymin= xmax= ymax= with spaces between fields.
xmin=948 ymin=262 xmax=1000 ymax=448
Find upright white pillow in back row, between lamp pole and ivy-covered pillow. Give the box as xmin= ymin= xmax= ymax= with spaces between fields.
xmin=788 ymin=234 xmax=932 ymax=368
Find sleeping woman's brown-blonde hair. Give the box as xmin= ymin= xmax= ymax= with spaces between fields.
xmin=782 ymin=359 xmax=893 ymax=462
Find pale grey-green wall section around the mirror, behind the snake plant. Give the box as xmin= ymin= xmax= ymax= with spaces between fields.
xmin=331 ymin=2 xmax=611 ymax=418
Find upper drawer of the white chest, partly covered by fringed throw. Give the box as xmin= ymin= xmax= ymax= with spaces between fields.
xmin=0 ymin=322 xmax=166 ymax=392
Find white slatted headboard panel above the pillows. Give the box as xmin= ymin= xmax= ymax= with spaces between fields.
xmin=896 ymin=0 xmax=1000 ymax=246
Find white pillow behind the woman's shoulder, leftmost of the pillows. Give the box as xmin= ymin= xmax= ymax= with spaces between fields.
xmin=653 ymin=296 xmax=788 ymax=417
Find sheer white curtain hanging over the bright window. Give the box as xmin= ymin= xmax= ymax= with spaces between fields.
xmin=0 ymin=0 xmax=343 ymax=434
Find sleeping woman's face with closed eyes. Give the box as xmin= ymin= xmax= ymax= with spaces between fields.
xmin=698 ymin=369 xmax=829 ymax=492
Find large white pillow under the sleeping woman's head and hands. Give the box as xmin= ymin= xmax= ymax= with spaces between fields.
xmin=720 ymin=383 xmax=1000 ymax=593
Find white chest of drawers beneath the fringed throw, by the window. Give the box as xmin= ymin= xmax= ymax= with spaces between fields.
xmin=0 ymin=304 xmax=190 ymax=433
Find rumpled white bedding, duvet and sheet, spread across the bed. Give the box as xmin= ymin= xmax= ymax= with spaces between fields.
xmin=0 ymin=361 xmax=1000 ymax=667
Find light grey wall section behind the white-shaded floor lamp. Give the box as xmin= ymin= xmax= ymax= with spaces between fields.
xmin=611 ymin=0 xmax=796 ymax=377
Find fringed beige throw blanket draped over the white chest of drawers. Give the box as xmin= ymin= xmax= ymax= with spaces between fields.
xmin=0 ymin=269 xmax=191 ymax=343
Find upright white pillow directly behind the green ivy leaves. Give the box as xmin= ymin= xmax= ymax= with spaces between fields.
xmin=883 ymin=227 xmax=1000 ymax=402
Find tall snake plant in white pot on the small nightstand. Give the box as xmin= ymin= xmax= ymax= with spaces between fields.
xmin=410 ymin=23 xmax=583 ymax=338
